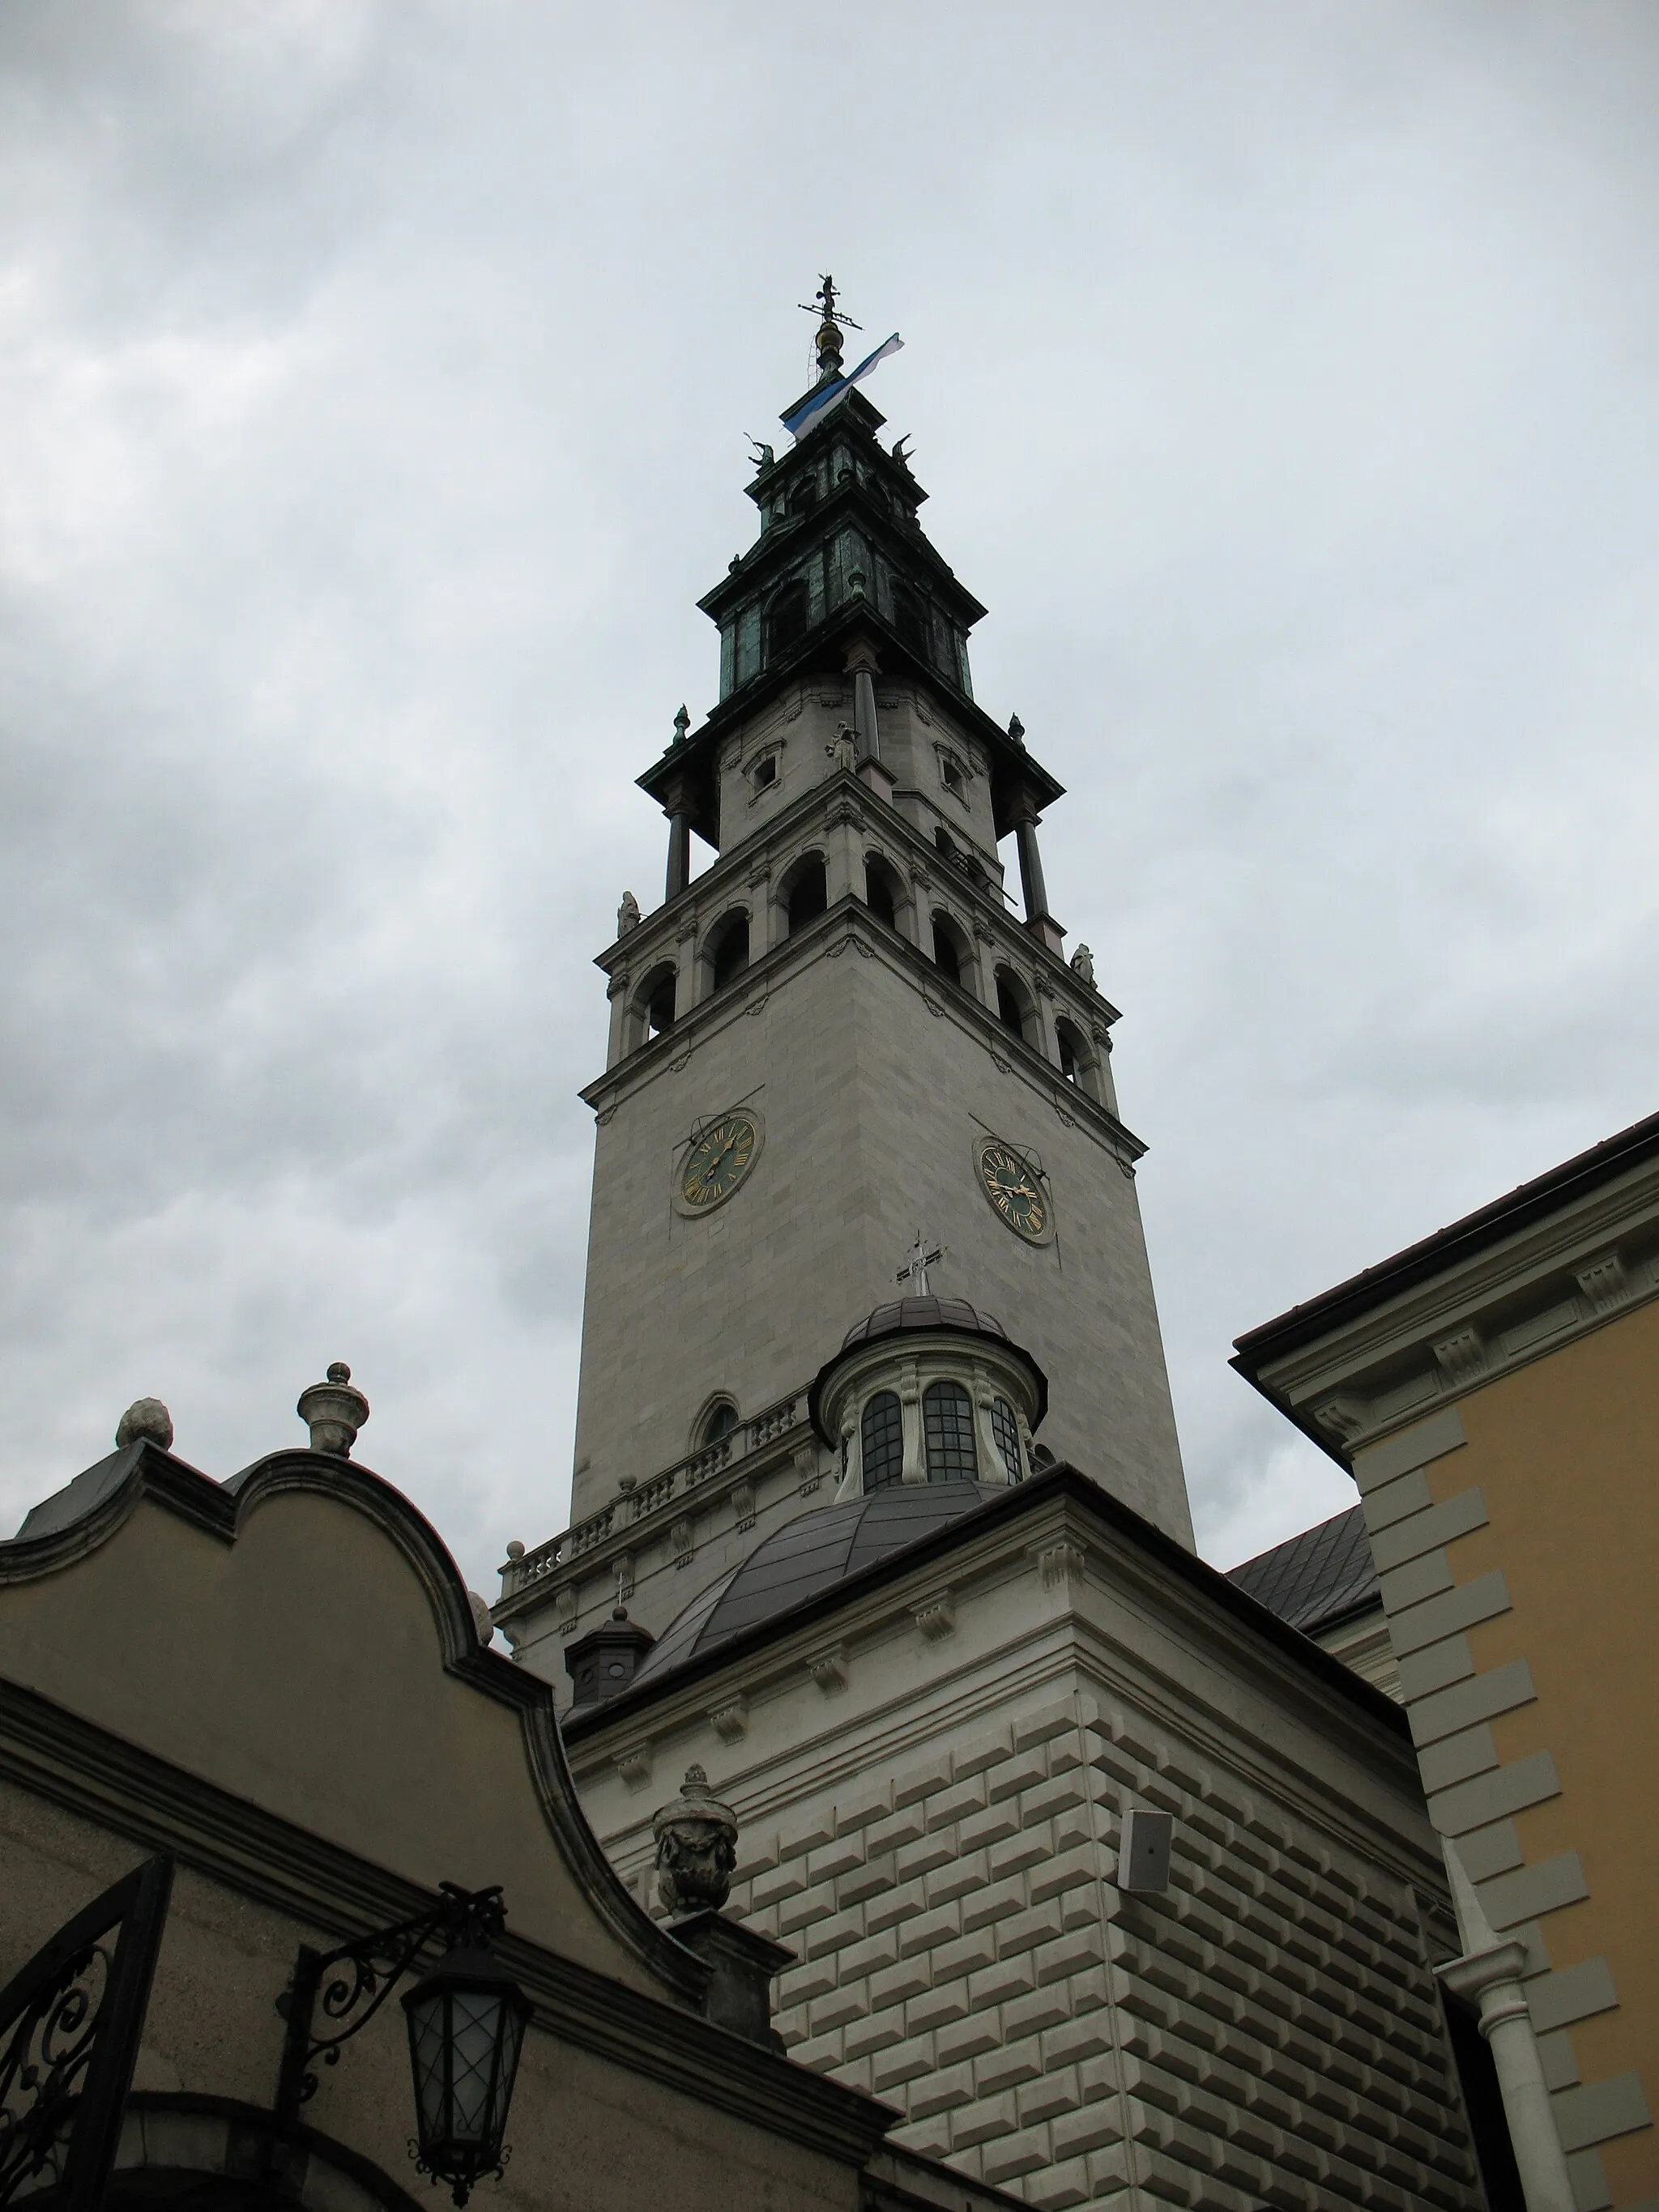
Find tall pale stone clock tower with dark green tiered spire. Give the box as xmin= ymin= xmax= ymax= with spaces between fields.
xmin=497 ymin=283 xmax=1192 ymax=1679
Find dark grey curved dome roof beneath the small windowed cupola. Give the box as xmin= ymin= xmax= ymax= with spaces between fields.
xmin=630 ymin=1486 xmax=1004 ymax=1688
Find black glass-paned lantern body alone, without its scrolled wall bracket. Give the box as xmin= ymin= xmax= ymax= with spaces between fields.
xmin=403 ymin=1924 xmax=531 ymax=2206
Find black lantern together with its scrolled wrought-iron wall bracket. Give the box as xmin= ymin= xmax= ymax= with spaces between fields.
xmin=276 ymin=1882 xmax=531 ymax=2206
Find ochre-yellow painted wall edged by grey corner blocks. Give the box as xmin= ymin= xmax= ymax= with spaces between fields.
xmin=1429 ymin=1305 xmax=1659 ymax=2206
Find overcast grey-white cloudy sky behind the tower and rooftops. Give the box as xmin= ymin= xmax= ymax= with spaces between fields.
xmin=0 ymin=0 xmax=1659 ymax=1595
